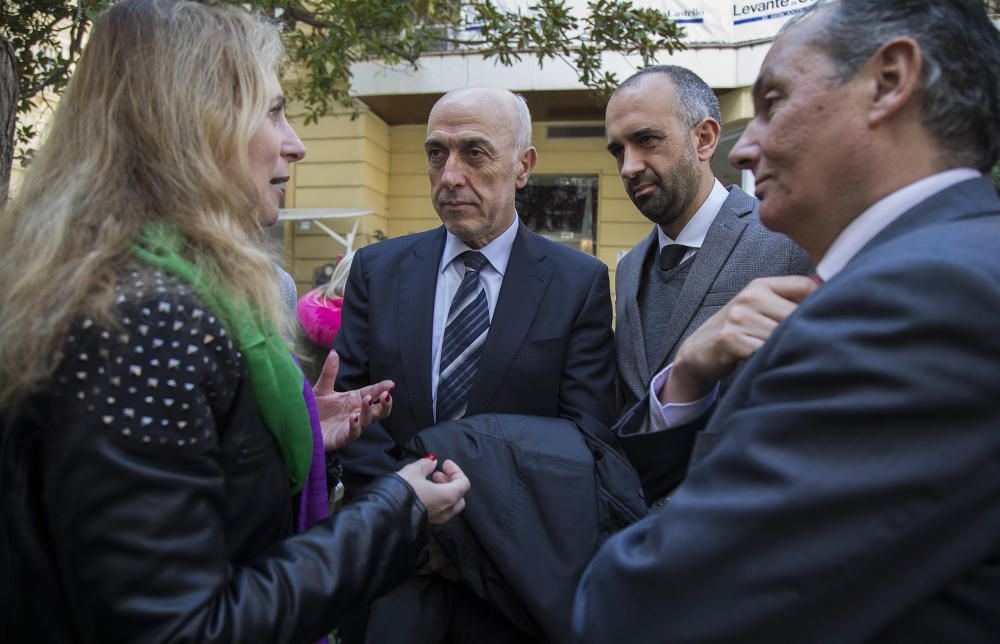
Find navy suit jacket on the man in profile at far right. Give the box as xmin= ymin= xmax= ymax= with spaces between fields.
xmin=574 ymin=179 xmax=1000 ymax=643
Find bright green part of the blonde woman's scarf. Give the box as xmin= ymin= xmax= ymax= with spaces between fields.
xmin=132 ymin=222 xmax=313 ymax=494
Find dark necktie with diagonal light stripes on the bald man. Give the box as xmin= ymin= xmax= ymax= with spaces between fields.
xmin=437 ymin=250 xmax=490 ymax=422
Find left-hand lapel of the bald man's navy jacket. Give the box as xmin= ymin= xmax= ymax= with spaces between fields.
xmin=398 ymin=226 xmax=445 ymax=427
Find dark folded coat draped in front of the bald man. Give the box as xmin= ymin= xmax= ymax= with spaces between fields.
xmin=408 ymin=414 xmax=646 ymax=642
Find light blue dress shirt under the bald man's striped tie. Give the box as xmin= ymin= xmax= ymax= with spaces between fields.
xmin=431 ymin=212 xmax=520 ymax=420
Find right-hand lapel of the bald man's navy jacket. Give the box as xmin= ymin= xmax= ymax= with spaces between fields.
xmin=466 ymin=223 xmax=552 ymax=416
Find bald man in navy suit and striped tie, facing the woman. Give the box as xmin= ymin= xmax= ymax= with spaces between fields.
xmin=334 ymin=88 xmax=615 ymax=487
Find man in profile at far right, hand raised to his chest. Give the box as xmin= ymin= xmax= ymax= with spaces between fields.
xmin=574 ymin=0 xmax=1000 ymax=643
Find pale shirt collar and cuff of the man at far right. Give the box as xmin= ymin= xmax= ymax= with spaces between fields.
xmin=649 ymin=168 xmax=981 ymax=431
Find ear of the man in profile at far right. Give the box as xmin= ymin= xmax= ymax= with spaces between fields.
xmin=868 ymin=37 xmax=923 ymax=126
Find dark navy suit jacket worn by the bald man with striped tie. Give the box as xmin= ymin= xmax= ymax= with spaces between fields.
xmin=334 ymin=224 xmax=615 ymax=485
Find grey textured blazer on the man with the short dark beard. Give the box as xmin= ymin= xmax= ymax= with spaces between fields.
xmin=615 ymin=186 xmax=813 ymax=411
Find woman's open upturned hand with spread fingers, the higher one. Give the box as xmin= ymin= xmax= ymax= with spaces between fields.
xmin=313 ymin=351 xmax=396 ymax=452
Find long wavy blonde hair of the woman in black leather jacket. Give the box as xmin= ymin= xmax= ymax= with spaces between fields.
xmin=0 ymin=0 xmax=289 ymax=410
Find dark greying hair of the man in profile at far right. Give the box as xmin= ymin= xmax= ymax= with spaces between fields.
xmin=786 ymin=0 xmax=1000 ymax=172
